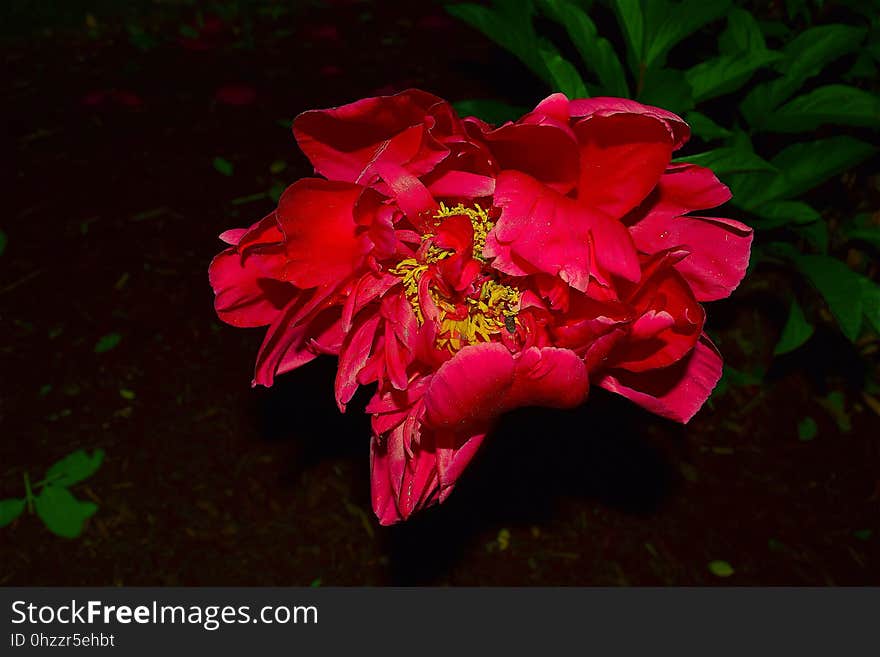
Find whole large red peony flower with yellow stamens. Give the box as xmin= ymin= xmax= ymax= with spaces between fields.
xmin=209 ymin=90 xmax=751 ymax=524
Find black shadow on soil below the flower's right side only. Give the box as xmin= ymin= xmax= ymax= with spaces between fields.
xmin=385 ymin=391 xmax=681 ymax=586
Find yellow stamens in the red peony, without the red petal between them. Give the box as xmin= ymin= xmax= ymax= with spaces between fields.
xmin=389 ymin=203 xmax=520 ymax=353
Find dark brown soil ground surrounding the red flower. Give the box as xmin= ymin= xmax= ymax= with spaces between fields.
xmin=0 ymin=2 xmax=880 ymax=586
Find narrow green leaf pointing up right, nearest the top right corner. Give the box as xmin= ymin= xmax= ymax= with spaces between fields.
xmin=740 ymin=24 xmax=865 ymax=127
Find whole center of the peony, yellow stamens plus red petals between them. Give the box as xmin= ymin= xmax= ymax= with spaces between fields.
xmin=389 ymin=203 xmax=520 ymax=353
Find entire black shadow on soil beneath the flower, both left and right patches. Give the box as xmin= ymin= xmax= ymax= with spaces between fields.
xmin=248 ymin=358 xmax=684 ymax=585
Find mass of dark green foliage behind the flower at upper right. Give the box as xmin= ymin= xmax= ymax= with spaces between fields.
xmin=448 ymin=0 xmax=880 ymax=354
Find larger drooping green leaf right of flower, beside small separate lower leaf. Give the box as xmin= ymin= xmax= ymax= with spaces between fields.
xmin=794 ymin=255 xmax=862 ymax=342
